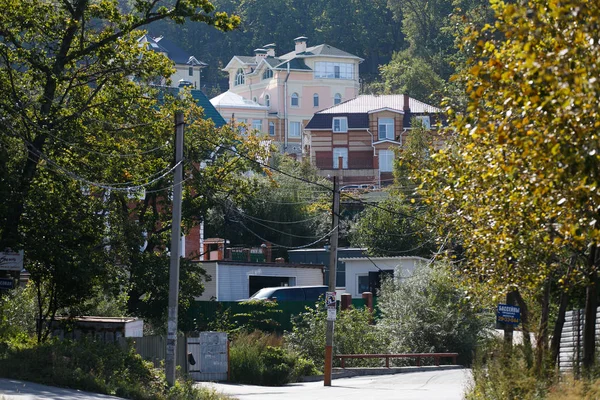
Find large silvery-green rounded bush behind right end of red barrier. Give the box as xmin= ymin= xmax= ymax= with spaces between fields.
xmin=377 ymin=265 xmax=492 ymax=365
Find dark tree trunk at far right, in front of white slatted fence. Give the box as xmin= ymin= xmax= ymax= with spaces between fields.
xmin=583 ymin=245 xmax=598 ymax=375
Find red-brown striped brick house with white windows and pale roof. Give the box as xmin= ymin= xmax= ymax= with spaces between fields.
xmin=305 ymin=95 xmax=442 ymax=186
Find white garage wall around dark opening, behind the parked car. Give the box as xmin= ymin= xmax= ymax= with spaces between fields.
xmin=218 ymin=263 xmax=323 ymax=301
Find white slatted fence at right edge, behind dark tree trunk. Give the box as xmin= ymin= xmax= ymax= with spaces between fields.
xmin=558 ymin=307 xmax=600 ymax=371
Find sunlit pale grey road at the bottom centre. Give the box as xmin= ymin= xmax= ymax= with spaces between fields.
xmin=202 ymin=369 xmax=471 ymax=400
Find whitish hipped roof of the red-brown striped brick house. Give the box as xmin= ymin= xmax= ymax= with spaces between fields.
xmin=317 ymin=94 xmax=442 ymax=114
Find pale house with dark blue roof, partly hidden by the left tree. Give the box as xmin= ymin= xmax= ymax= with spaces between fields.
xmin=138 ymin=34 xmax=208 ymax=89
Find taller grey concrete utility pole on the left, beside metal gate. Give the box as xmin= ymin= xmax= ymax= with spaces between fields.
xmin=165 ymin=112 xmax=184 ymax=386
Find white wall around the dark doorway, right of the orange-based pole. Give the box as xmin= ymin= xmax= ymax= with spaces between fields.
xmin=340 ymin=257 xmax=428 ymax=299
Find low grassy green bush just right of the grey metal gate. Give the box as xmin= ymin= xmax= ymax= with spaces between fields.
xmin=229 ymin=331 xmax=316 ymax=386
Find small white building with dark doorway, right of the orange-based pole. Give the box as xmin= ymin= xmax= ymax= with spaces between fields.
xmin=339 ymin=257 xmax=429 ymax=299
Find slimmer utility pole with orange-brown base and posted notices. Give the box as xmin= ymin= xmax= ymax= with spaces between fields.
xmin=323 ymin=176 xmax=340 ymax=386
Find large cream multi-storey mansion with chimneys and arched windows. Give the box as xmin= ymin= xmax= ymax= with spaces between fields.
xmin=218 ymin=36 xmax=363 ymax=158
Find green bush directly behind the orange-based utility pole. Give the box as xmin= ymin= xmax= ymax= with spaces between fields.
xmin=285 ymin=303 xmax=388 ymax=365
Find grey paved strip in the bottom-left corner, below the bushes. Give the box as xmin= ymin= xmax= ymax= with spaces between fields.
xmin=0 ymin=378 xmax=123 ymax=400
